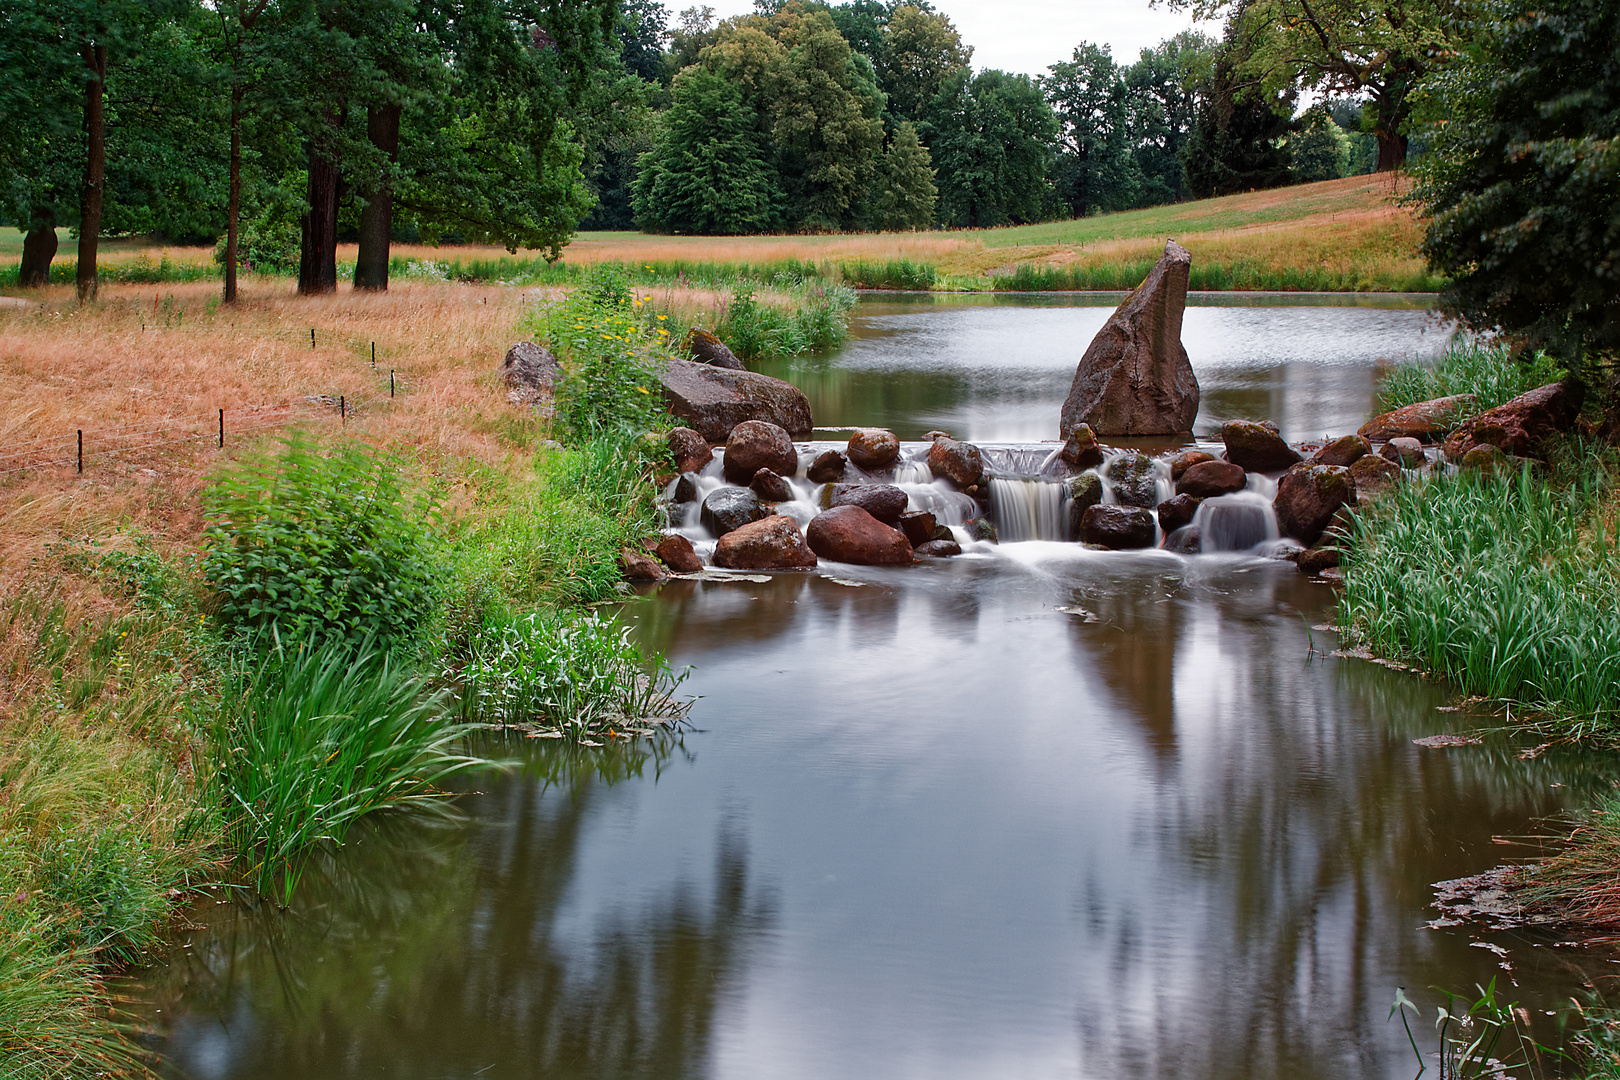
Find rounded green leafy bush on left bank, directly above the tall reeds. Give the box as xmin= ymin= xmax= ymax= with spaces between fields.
xmin=203 ymin=436 xmax=437 ymax=641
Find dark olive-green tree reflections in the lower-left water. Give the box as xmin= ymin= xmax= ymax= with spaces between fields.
xmin=131 ymin=735 xmax=774 ymax=1078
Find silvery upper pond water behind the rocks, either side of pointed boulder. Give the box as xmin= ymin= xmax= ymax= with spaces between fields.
xmin=760 ymin=293 xmax=1450 ymax=440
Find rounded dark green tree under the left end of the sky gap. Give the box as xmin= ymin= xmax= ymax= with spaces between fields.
xmin=925 ymin=68 xmax=1058 ymax=228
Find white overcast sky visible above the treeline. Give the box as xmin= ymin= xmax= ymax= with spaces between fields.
xmin=696 ymin=0 xmax=1218 ymax=74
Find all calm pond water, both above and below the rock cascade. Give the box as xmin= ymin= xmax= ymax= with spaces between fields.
xmin=131 ymin=298 xmax=1615 ymax=1080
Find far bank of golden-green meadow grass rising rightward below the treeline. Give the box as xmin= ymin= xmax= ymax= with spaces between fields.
xmin=0 ymin=175 xmax=1443 ymax=295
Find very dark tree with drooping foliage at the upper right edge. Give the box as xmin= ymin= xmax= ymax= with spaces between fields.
xmin=1411 ymin=0 xmax=1620 ymax=371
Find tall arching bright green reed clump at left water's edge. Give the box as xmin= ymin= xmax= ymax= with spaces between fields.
xmin=212 ymin=636 xmax=489 ymax=905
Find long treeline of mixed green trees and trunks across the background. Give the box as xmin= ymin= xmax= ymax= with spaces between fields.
xmin=0 ymin=0 xmax=1411 ymax=283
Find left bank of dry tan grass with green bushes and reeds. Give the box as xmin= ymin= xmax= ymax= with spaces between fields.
xmin=0 ymin=272 xmax=709 ymax=1077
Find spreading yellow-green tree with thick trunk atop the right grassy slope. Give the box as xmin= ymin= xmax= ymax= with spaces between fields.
xmin=1170 ymin=0 xmax=1468 ymax=172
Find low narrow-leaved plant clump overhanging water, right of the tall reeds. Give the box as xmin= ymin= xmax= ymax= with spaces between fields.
xmin=454 ymin=612 xmax=685 ymax=742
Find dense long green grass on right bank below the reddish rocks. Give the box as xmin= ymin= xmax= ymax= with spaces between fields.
xmin=1340 ymin=444 xmax=1620 ymax=740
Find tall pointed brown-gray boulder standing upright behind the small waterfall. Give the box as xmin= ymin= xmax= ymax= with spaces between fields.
xmin=1058 ymin=240 xmax=1199 ymax=437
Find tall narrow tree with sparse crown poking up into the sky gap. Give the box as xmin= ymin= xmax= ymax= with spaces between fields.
xmin=1038 ymin=42 xmax=1140 ymax=217
